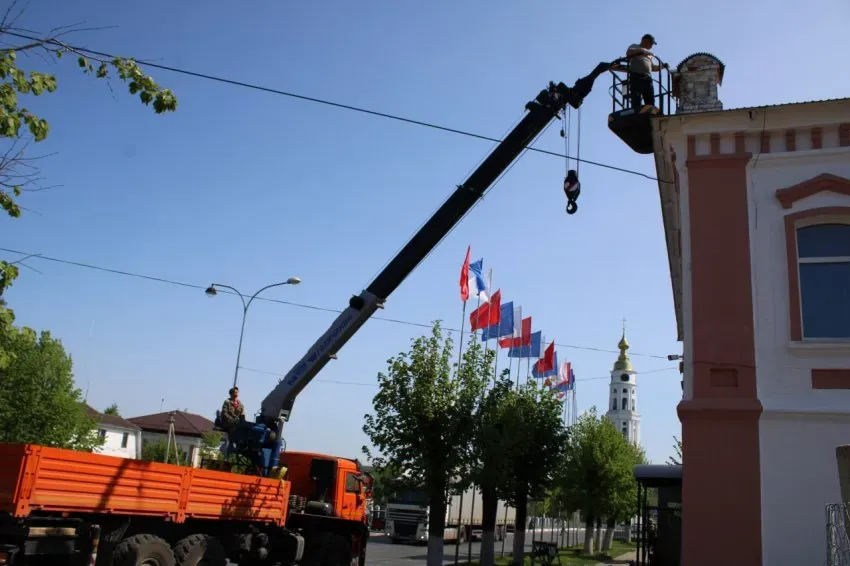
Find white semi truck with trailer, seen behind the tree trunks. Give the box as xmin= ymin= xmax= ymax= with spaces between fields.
xmin=386 ymin=488 xmax=516 ymax=544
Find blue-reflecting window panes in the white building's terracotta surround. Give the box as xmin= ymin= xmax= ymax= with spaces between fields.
xmin=796 ymin=220 xmax=850 ymax=339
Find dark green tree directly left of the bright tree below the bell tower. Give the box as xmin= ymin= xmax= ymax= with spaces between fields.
xmin=498 ymin=381 xmax=569 ymax=566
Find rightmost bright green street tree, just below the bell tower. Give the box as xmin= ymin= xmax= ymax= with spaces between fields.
xmin=558 ymin=407 xmax=642 ymax=554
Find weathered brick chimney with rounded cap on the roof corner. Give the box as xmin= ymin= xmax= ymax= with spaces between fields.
xmin=672 ymin=53 xmax=726 ymax=114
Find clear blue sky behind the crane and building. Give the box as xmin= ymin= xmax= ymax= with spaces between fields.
xmin=2 ymin=0 xmax=850 ymax=462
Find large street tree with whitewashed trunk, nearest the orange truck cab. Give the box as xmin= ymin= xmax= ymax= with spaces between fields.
xmin=363 ymin=322 xmax=486 ymax=564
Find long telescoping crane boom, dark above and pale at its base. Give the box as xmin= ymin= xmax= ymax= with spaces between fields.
xmin=261 ymin=63 xmax=613 ymax=433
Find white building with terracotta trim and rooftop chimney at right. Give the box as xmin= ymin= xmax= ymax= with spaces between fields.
xmin=653 ymin=53 xmax=850 ymax=566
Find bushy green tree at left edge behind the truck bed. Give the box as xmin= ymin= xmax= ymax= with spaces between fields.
xmin=0 ymin=327 xmax=104 ymax=451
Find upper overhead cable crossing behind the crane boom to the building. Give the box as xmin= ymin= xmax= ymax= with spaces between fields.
xmin=4 ymin=31 xmax=669 ymax=183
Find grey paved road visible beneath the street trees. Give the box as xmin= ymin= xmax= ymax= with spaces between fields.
xmin=366 ymin=528 xmax=584 ymax=566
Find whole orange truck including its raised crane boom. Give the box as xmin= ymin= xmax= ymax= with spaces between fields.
xmin=0 ymin=62 xmax=614 ymax=566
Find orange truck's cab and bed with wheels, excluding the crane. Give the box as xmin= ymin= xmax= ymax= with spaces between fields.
xmin=0 ymin=444 xmax=371 ymax=566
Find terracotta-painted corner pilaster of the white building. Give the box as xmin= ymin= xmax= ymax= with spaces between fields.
xmin=678 ymin=151 xmax=762 ymax=566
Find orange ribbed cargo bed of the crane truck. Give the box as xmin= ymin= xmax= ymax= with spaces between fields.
xmin=0 ymin=444 xmax=290 ymax=525
